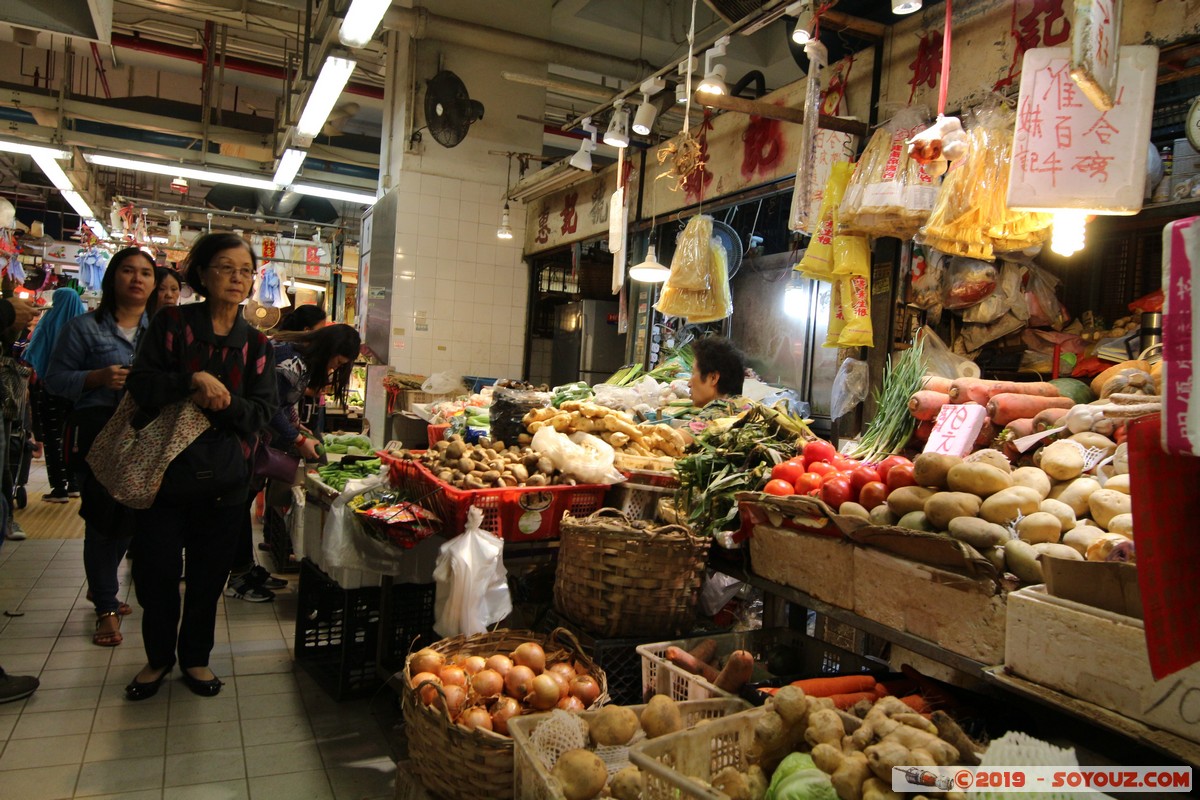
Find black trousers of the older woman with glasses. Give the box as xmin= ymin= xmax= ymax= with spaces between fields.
xmin=133 ymin=501 xmax=246 ymax=669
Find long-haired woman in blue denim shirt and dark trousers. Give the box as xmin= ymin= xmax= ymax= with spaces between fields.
xmin=44 ymin=247 xmax=153 ymax=648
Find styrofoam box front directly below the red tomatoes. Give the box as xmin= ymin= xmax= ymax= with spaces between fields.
xmin=750 ymin=525 xmax=854 ymax=608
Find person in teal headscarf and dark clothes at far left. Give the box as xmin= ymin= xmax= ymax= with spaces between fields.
xmin=25 ymin=288 xmax=88 ymax=503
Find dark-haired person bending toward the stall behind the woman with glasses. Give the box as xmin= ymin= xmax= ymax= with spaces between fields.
xmin=226 ymin=325 xmax=362 ymax=602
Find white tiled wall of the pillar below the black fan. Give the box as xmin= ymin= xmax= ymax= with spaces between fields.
xmin=389 ymin=173 xmax=529 ymax=378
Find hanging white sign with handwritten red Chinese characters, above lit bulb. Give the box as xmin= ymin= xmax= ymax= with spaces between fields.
xmin=1008 ymin=46 xmax=1158 ymax=213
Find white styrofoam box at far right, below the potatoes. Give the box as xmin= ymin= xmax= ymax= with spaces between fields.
xmin=1004 ymin=585 xmax=1200 ymax=741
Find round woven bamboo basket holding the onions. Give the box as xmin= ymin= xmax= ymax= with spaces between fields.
xmin=401 ymin=628 xmax=608 ymax=800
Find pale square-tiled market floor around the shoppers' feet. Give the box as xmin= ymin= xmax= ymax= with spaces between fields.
xmin=0 ymin=510 xmax=396 ymax=800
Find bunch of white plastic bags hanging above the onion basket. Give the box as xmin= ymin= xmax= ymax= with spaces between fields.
xmin=433 ymin=506 xmax=512 ymax=637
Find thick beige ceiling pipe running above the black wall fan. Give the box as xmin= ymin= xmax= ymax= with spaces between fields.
xmin=383 ymin=6 xmax=653 ymax=80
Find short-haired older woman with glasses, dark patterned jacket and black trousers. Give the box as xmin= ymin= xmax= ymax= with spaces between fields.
xmin=125 ymin=234 xmax=276 ymax=700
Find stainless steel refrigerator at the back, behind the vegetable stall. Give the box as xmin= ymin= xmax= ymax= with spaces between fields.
xmin=550 ymin=300 xmax=625 ymax=386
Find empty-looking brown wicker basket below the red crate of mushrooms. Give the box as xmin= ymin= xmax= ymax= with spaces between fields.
xmin=554 ymin=509 xmax=712 ymax=638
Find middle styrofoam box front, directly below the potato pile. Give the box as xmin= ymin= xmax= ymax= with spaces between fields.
xmin=853 ymin=547 xmax=1007 ymax=664
